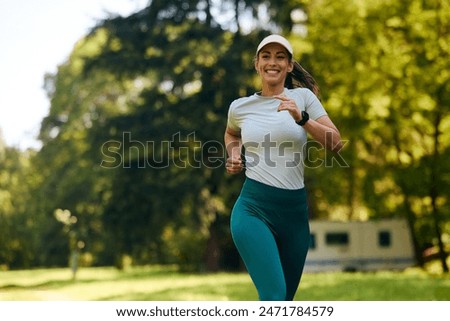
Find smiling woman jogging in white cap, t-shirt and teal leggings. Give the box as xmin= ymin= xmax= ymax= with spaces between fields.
xmin=224 ymin=35 xmax=342 ymax=301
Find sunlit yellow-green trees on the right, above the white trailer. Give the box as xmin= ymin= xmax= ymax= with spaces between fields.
xmin=308 ymin=1 xmax=449 ymax=271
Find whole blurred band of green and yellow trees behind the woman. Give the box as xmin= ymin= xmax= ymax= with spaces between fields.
xmin=0 ymin=0 xmax=450 ymax=271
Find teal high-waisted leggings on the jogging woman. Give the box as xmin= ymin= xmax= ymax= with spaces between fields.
xmin=231 ymin=178 xmax=310 ymax=301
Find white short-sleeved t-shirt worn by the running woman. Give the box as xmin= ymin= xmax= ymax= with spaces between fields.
xmin=227 ymin=88 xmax=327 ymax=189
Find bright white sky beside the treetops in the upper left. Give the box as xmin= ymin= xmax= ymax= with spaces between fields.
xmin=0 ymin=0 xmax=149 ymax=150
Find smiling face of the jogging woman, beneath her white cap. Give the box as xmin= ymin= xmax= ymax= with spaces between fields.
xmin=255 ymin=43 xmax=294 ymax=86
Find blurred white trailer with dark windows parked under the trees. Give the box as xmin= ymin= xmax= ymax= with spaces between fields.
xmin=304 ymin=219 xmax=415 ymax=272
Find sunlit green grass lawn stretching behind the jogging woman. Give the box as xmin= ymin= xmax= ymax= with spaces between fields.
xmin=0 ymin=266 xmax=450 ymax=301
